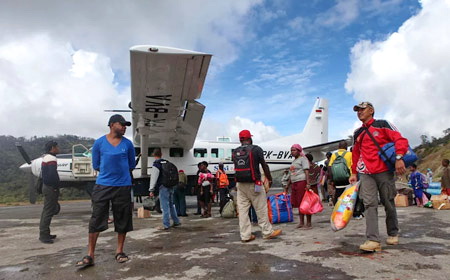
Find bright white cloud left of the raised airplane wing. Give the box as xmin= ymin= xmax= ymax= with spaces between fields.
xmin=0 ymin=35 xmax=129 ymax=139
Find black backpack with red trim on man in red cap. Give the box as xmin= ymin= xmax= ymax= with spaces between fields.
xmin=233 ymin=145 xmax=258 ymax=183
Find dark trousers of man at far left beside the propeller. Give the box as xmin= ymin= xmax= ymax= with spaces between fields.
xmin=39 ymin=185 xmax=60 ymax=239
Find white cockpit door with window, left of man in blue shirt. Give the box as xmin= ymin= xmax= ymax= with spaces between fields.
xmin=71 ymin=144 xmax=97 ymax=177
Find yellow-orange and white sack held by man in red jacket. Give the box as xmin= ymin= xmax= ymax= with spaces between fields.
xmin=330 ymin=182 xmax=359 ymax=231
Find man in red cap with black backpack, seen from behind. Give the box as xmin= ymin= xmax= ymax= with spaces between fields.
xmin=233 ymin=130 xmax=281 ymax=242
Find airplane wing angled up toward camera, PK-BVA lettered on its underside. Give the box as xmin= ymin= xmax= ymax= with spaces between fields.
xmin=130 ymin=45 xmax=211 ymax=149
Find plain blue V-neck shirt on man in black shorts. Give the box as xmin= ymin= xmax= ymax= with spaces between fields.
xmin=92 ymin=135 xmax=136 ymax=187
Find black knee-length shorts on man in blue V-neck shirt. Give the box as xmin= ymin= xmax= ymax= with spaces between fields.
xmin=89 ymin=185 xmax=133 ymax=233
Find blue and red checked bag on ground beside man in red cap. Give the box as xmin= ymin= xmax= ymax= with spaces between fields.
xmin=267 ymin=193 xmax=294 ymax=224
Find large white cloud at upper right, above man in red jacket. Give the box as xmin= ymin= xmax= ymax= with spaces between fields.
xmin=345 ymin=0 xmax=450 ymax=145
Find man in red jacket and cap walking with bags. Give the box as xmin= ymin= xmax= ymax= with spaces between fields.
xmin=349 ymin=102 xmax=408 ymax=252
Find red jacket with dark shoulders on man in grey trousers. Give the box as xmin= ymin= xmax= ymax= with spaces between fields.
xmin=352 ymin=119 xmax=408 ymax=174
